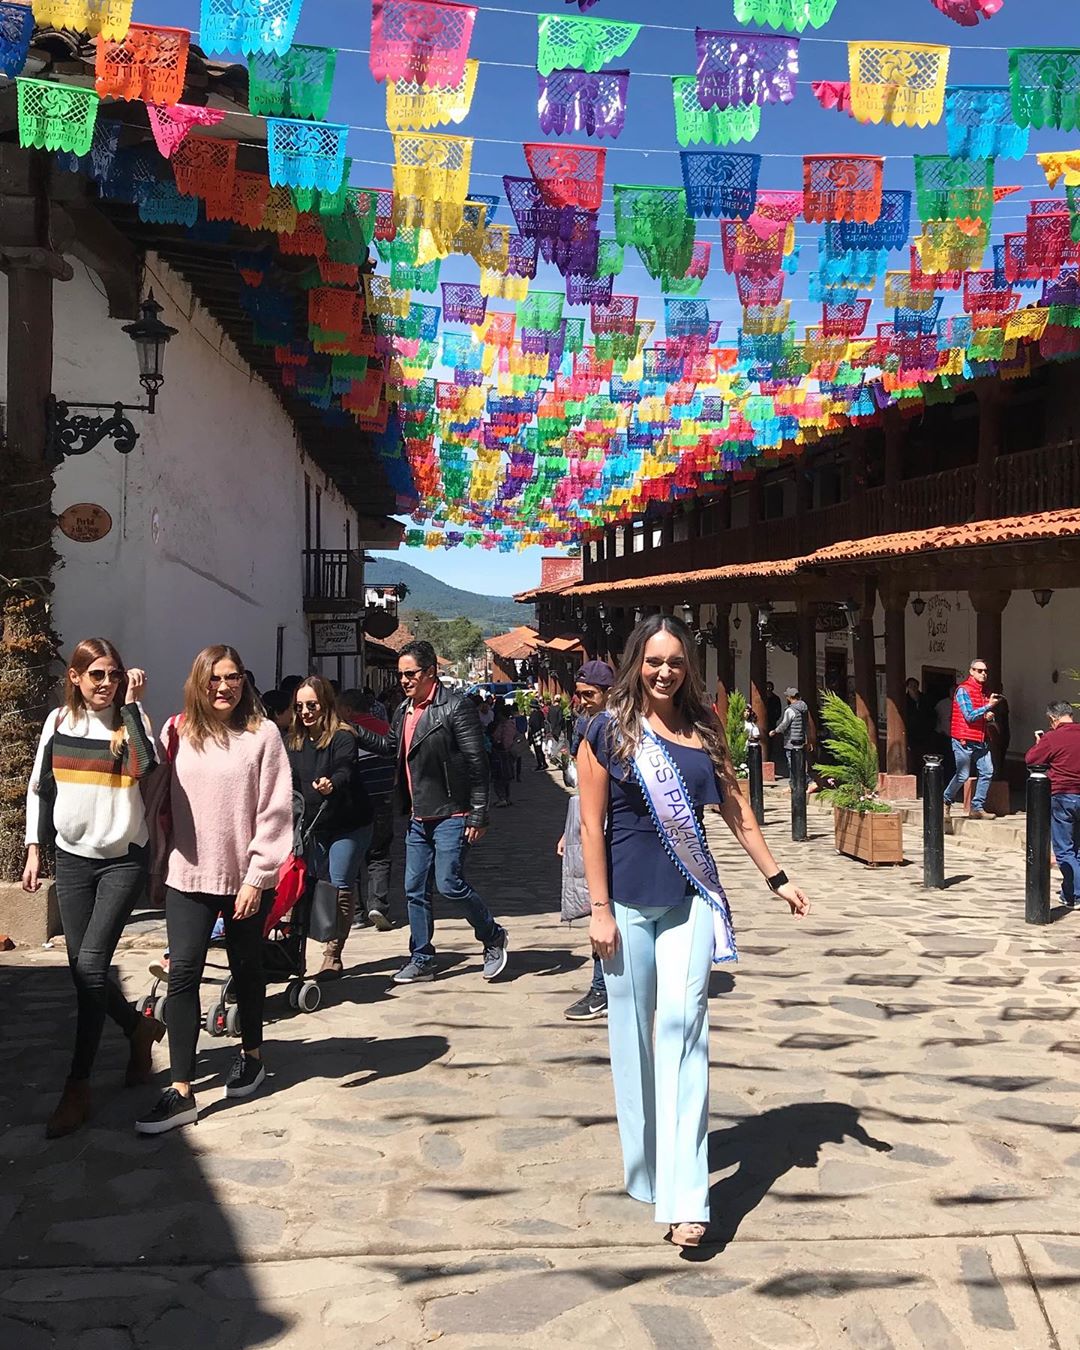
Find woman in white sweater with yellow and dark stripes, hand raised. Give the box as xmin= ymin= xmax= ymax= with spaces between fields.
xmin=23 ymin=637 xmax=165 ymax=1139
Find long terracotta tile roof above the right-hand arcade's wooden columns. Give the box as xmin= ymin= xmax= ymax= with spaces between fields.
xmin=561 ymin=508 xmax=1080 ymax=599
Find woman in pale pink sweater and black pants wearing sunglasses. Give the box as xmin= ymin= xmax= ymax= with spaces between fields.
xmin=135 ymin=647 xmax=293 ymax=1134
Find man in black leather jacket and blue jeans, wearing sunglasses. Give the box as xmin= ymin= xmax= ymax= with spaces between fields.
xmin=355 ymin=641 xmax=509 ymax=984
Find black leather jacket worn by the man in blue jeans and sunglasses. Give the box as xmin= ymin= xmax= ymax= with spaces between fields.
xmin=355 ymin=684 xmax=490 ymax=829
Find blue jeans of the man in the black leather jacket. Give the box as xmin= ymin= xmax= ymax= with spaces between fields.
xmin=405 ymin=815 xmax=502 ymax=963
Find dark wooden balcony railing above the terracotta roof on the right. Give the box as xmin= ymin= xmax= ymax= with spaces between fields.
xmin=585 ymin=441 xmax=1080 ymax=582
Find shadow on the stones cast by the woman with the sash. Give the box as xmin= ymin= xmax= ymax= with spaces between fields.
xmin=684 ymin=1102 xmax=892 ymax=1260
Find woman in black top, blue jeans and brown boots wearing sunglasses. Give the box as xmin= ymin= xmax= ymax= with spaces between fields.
xmin=285 ymin=675 xmax=373 ymax=980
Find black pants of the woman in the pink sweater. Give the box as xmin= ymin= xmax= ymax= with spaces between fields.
xmin=165 ymin=886 xmax=274 ymax=1083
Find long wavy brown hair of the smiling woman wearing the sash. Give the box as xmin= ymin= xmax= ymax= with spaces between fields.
xmin=608 ymin=614 xmax=732 ymax=779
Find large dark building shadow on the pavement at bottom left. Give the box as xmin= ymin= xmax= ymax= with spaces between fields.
xmin=0 ymin=959 xmax=290 ymax=1350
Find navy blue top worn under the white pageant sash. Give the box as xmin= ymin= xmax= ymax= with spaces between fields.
xmin=585 ymin=713 xmax=724 ymax=909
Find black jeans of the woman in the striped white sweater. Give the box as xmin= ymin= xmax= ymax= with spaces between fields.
xmin=57 ymin=844 xmax=147 ymax=1081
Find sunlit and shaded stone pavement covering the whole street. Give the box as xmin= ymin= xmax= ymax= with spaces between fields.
xmin=0 ymin=770 xmax=1080 ymax=1350
